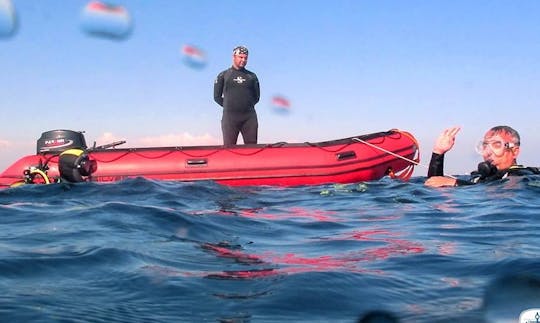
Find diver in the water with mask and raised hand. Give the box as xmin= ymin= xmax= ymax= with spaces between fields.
xmin=425 ymin=126 xmax=540 ymax=187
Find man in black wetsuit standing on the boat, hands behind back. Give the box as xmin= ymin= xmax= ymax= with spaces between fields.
xmin=214 ymin=46 xmax=260 ymax=146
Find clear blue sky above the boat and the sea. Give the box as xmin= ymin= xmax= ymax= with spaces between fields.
xmin=0 ymin=0 xmax=540 ymax=176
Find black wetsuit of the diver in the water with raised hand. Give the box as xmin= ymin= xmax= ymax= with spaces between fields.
xmin=427 ymin=153 xmax=540 ymax=186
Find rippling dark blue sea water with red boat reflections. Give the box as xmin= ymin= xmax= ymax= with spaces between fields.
xmin=0 ymin=177 xmax=540 ymax=322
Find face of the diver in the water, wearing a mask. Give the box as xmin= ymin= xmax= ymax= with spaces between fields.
xmin=481 ymin=132 xmax=519 ymax=170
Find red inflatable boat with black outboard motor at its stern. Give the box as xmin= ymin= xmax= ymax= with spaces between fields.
xmin=0 ymin=130 xmax=420 ymax=188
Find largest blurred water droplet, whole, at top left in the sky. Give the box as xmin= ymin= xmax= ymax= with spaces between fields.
xmin=81 ymin=1 xmax=132 ymax=40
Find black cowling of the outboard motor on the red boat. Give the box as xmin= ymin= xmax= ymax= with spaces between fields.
xmin=37 ymin=130 xmax=87 ymax=154
